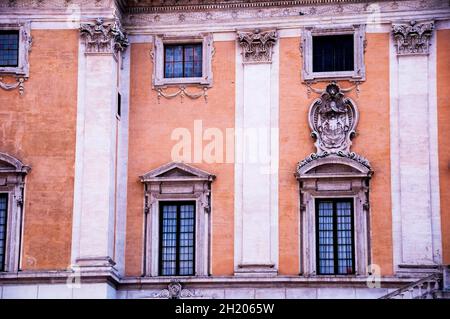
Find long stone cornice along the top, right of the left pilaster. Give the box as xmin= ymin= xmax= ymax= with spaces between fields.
xmin=124 ymin=0 xmax=448 ymax=32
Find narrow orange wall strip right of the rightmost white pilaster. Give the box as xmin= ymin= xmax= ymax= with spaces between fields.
xmin=437 ymin=30 xmax=450 ymax=265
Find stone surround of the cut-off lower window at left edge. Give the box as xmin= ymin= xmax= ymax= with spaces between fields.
xmin=0 ymin=153 xmax=31 ymax=272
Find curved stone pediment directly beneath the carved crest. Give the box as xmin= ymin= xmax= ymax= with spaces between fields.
xmin=296 ymin=153 xmax=373 ymax=178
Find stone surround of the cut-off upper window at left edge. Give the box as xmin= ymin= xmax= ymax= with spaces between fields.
xmin=0 ymin=22 xmax=31 ymax=78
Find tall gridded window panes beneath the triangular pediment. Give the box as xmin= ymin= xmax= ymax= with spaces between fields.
xmin=159 ymin=202 xmax=195 ymax=276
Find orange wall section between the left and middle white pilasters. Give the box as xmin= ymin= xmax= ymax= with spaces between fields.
xmin=126 ymin=41 xmax=235 ymax=276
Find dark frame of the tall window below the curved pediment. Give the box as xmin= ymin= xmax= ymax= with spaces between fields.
xmin=315 ymin=197 xmax=356 ymax=276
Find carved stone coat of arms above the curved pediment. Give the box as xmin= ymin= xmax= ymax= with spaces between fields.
xmin=309 ymin=82 xmax=358 ymax=154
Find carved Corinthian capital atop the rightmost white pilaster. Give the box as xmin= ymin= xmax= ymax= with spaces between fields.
xmin=392 ymin=21 xmax=434 ymax=55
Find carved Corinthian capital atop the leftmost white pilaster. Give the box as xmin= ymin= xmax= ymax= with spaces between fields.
xmin=80 ymin=18 xmax=130 ymax=53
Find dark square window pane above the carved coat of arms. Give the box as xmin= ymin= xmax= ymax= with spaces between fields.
xmin=313 ymin=34 xmax=354 ymax=72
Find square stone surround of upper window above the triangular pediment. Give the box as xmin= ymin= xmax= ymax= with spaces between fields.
xmin=153 ymin=33 xmax=214 ymax=87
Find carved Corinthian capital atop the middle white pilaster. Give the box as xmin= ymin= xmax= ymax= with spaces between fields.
xmin=237 ymin=29 xmax=278 ymax=63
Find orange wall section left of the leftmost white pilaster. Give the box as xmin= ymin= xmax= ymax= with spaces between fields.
xmin=0 ymin=30 xmax=79 ymax=269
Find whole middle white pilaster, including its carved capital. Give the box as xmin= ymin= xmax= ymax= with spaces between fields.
xmin=235 ymin=30 xmax=278 ymax=275
